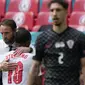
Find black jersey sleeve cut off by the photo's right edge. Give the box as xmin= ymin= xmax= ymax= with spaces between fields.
xmin=79 ymin=34 xmax=85 ymax=58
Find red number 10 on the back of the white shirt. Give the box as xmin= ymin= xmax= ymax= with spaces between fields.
xmin=8 ymin=61 xmax=23 ymax=84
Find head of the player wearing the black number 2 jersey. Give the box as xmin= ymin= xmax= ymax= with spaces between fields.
xmin=48 ymin=0 xmax=68 ymax=26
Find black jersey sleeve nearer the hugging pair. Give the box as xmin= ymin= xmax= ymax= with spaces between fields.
xmin=33 ymin=34 xmax=45 ymax=62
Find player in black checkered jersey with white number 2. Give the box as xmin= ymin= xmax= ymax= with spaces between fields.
xmin=28 ymin=0 xmax=85 ymax=85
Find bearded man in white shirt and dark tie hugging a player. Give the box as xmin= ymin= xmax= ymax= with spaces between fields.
xmin=0 ymin=19 xmax=31 ymax=71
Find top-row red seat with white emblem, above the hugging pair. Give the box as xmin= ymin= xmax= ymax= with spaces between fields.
xmin=8 ymin=0 xmax=39 ymax=15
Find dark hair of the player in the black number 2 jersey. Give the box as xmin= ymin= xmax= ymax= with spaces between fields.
xmin=48 ymin=0 xmax=68 ymax=9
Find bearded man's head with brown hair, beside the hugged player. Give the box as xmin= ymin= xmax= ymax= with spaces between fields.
xmin=0 ymin=19 xmax=17 ymax=45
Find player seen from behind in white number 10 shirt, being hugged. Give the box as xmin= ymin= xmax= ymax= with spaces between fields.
xmin=2 ymin=27 xmax=35 ymax=85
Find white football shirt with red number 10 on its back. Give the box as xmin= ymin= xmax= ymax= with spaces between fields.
xmin=2 ymin=46 xmax=35 ymax=85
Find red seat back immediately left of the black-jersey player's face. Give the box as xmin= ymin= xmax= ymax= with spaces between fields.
xmin=37 ymin=12 xmax=52 ymax=25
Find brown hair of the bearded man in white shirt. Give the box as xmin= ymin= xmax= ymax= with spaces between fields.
xmin=0 ymin=19 xmax=17 ymax=31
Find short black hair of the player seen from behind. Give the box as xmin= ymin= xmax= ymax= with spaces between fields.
xmin=15 ymin=27 xmax=31 ymax=45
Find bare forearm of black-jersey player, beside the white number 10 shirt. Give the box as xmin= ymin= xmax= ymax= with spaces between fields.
xmin=27 ymin=60 xmax=41 ymax=85
